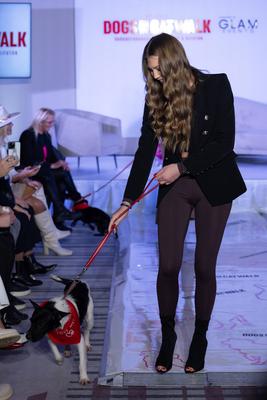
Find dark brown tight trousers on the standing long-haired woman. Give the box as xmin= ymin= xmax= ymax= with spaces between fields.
xmin=157 ymin=177 xmax=232 ymax=320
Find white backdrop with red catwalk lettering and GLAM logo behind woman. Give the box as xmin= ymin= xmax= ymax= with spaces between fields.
xmin=75 ymin=0 xmax=267 ymax=146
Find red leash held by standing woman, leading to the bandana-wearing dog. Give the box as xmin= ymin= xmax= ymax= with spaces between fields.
xmin=64 ymin=174 xmax=159 ymax=298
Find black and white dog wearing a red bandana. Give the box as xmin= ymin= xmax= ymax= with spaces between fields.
xmin=26 ymin=275 xmax=94 ymax=385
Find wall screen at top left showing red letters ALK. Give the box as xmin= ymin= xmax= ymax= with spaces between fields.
xmin=0 ymin=3 xmax=31 ymax=78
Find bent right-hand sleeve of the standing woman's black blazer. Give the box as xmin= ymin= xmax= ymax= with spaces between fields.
xmin=183 ymin=74 xmax=235 ymax=175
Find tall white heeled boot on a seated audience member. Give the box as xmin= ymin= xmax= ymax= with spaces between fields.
xmin=34 ymin=210 xmax=72 ymax=256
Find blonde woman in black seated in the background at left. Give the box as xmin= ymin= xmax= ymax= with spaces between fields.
xmin=20 ymin=108 xmax=84 ymax=230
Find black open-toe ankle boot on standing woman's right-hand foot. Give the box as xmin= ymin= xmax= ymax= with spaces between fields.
xmin=184 ymin=319 xmax=209 ymax=374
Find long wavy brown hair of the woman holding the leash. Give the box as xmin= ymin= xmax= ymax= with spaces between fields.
xmin=142 ymin=33 xmax=196 ymax=152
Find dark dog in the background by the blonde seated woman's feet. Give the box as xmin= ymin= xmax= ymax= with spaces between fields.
xmin=71 ymin=200 xmax=110 ymax=236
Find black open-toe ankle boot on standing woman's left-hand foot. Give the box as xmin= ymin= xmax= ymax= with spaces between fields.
xmin=155 ymin=316 xmax=177 ymax=374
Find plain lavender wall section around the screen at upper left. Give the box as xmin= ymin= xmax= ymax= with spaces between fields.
xmin=0 ymin=0 xmax=76 ymax=138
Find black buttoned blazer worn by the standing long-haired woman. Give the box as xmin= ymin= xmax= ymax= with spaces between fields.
xmin=124 ymin=72 xmax=246 ymax=206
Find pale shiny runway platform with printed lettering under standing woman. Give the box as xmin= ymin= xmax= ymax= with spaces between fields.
xmin=69 ymin=156 xmax=267 ymax=386
